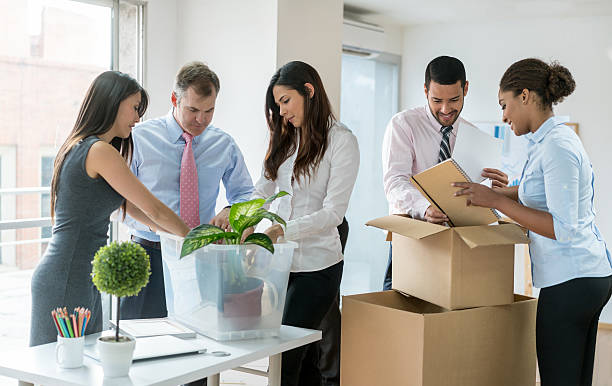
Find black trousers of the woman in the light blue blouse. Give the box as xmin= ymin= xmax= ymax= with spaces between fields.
xmin=536 ymin=276 xmax=612 ymax=386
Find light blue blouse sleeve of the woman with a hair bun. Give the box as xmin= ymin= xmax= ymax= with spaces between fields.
xmin=542 ymin=141 xmax=581 ymax=243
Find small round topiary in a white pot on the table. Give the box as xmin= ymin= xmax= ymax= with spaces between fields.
xmin=91 ymin=241 xmax=151 ymax=377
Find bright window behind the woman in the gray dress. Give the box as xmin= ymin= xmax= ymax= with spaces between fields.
xmin=0 ymin=0 xmax=144 ymax=356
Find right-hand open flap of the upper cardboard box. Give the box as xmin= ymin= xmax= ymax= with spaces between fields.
xmin=453 ymin=224 xmax=529 ymax=248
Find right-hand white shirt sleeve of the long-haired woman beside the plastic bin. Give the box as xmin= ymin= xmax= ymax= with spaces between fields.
xmin=285 ymin=131 xmax=359 ymax=240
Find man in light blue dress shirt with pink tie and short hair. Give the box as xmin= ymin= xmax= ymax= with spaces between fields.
xmin=121 ymin=62 xmax=253 ymax=332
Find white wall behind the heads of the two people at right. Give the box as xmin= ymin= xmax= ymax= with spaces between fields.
xmin=402 ymin=17 xmax=612 ymax=322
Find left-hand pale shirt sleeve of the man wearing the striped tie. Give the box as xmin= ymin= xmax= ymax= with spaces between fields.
xmin=382 ymin=116 xmax=430 ymax=219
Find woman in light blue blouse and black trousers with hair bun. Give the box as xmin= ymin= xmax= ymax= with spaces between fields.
xmin=454 ymin=59 xmax=612 ymax=386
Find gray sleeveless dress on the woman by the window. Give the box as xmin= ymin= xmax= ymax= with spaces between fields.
xmin=30 ymin=136 xmax=123 ymax=346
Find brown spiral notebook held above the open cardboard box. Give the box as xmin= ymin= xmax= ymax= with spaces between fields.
xmin=410 ymin=158 xmax=499 ymax=226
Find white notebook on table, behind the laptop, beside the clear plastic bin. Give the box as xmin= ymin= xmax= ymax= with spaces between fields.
xmin=110 ymin=318 xmax=196 ymax=338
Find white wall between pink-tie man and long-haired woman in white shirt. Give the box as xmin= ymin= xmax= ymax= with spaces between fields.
xmin=175 ymin=0 xmax=277 ymax=180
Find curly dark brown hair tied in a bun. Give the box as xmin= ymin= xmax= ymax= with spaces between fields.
xmin=499 ymin=58 xmax=576 ymax=109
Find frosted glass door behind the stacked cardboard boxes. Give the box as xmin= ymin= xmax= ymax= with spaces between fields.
xmin=340 ymin=50 xmax=400 ymax=295
